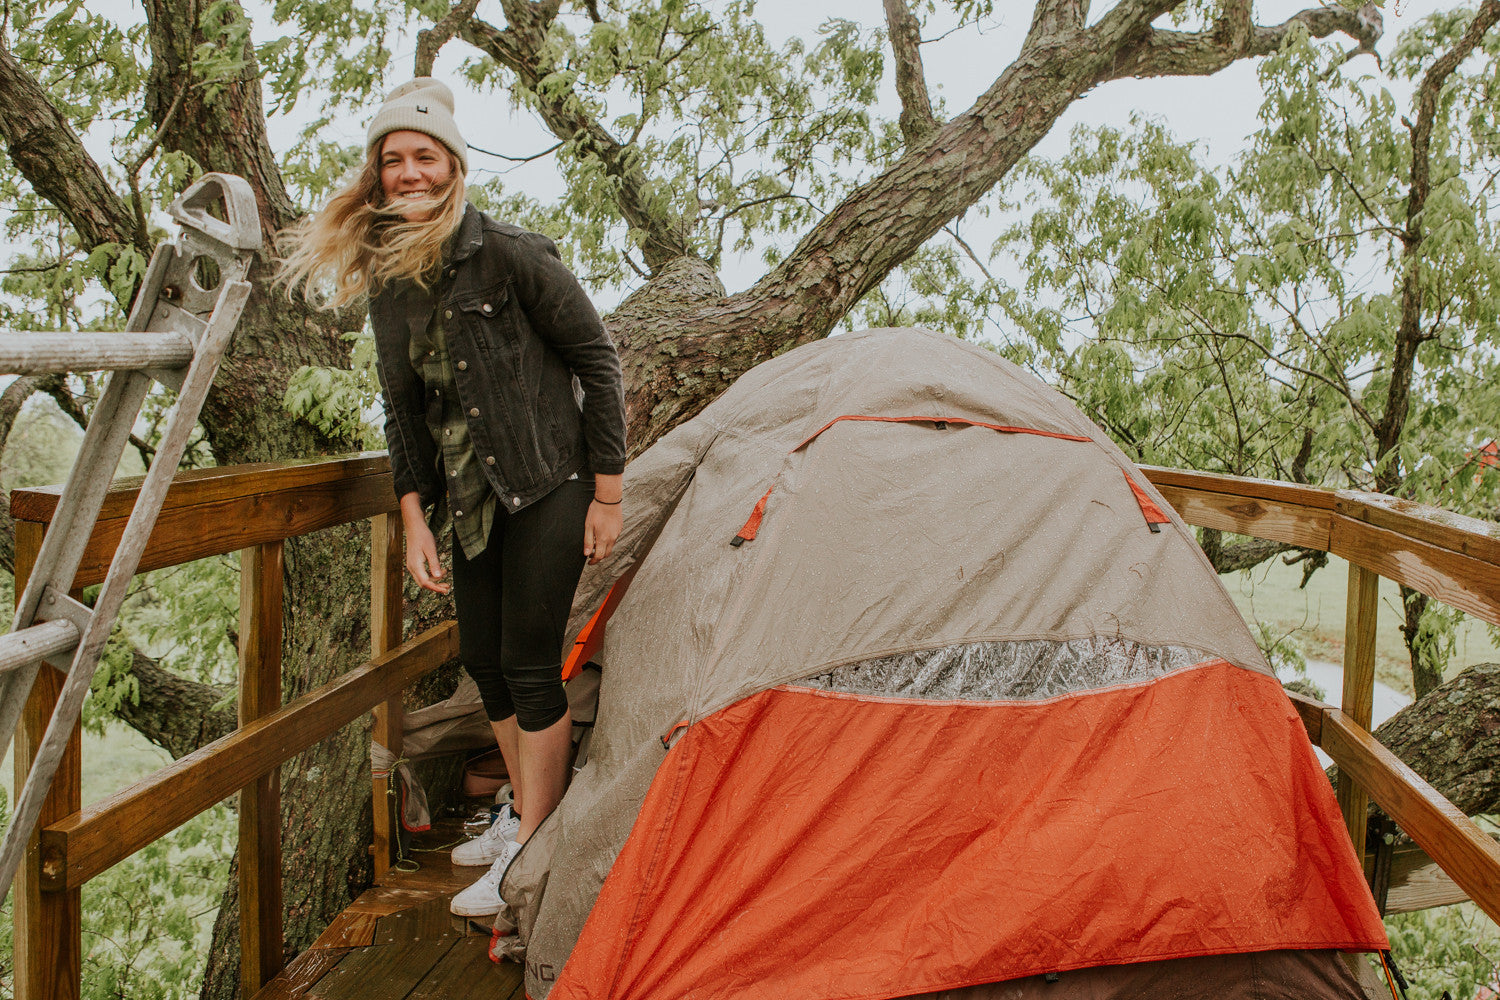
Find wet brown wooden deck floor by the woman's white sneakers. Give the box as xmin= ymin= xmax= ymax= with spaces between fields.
xmin=255 ymin=820 xmax=525 ymax=1000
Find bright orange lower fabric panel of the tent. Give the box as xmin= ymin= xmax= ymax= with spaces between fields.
xmin=549 ymin=660 xmax=1388 ymax=1000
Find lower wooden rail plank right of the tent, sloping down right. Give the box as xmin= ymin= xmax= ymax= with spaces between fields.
xmin=1323 ymin=709 xmax=1500 ymax=921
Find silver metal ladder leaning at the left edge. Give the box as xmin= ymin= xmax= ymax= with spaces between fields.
xmin=0 ymin=174 xmax=261 ymax=901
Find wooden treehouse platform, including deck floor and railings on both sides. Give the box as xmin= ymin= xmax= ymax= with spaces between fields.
xmin=2 ymin=453 xmax=1500 ymax=1000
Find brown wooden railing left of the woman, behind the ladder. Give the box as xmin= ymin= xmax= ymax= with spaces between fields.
xmin=12 ymin=453 xmax=441 ymax=1000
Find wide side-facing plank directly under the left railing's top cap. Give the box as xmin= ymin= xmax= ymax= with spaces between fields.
xmin=30 ymin=472 xmax=396 ymax=586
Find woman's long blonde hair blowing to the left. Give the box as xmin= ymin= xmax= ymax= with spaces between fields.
xmin=276 ymin=142 xmax=464 ymax=309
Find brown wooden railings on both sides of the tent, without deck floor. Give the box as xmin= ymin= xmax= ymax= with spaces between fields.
xmin=12 ymin=454 xmax=1500 ymax=1000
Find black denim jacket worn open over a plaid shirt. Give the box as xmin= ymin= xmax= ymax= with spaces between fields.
xmin=371 ymin=205 xmax=626 ymax=511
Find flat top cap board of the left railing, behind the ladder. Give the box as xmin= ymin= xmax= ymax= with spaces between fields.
xmin=11 ymin=451 xmax=396 ymax=523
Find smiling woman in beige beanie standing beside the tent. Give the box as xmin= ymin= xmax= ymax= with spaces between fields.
xmin=282 ymin=76 xmax=626 ymax=916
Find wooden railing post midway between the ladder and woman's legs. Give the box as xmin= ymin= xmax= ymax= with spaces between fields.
xmin=240 ymin=541 xmax=284 ymax=1000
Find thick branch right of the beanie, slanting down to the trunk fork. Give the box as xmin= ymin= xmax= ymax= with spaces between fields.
xmin=459 ymin=0 xmax=690 ymax=274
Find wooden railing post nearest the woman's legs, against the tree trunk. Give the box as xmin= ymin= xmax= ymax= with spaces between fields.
xmin=371 ymin=513 xmax=407 ymax=882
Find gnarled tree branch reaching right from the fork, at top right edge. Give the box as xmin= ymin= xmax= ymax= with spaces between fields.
xmin=1094 ymin=0 xmax=1382 ymax=82
